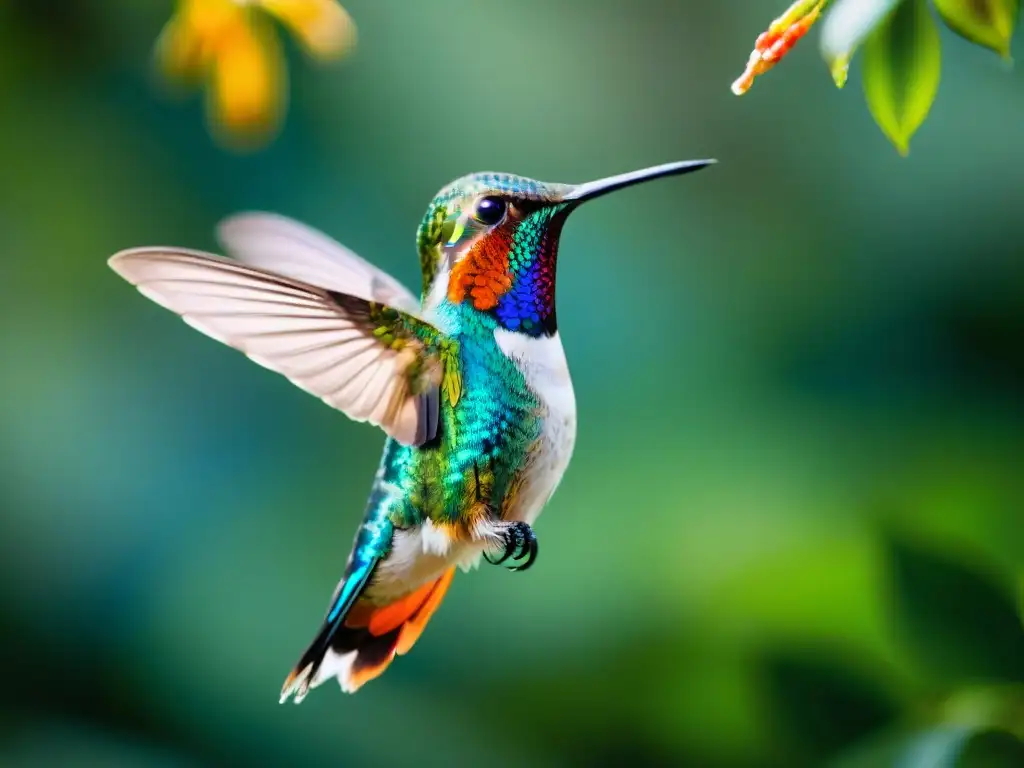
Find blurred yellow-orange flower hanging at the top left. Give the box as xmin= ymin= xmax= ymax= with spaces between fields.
xmin=157 ymin=0 xmax=355 ymax=148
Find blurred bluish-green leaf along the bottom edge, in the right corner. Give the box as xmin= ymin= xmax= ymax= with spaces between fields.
xmin=829 ymin=727 xmax=1024 ymax=768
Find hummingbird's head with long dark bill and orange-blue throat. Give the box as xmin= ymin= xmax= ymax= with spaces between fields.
xmin=417 ymin=160 xmax=715 ymax=336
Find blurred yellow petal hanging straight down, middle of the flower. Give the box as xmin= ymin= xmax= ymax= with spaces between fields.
xmin=211 ymin=17 xmax=287 ymax=143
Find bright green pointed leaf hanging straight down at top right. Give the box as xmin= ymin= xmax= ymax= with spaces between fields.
xmin=862 ymin=0 xmax=942 ymax=156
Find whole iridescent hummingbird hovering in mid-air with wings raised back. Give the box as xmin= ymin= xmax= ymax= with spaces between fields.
xmin=109 ymin=160 xmax=715 ymax=703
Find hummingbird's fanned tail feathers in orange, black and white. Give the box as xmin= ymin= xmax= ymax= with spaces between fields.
xmin=281 ymin=567 xmax=455 ymax=703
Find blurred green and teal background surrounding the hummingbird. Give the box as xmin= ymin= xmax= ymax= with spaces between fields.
xmin=0 ymin=0 xmax=1024 ymax=768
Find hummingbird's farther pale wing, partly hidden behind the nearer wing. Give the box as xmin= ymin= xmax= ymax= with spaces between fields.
xmin=217 ymin=213 xmax=420 ymax=315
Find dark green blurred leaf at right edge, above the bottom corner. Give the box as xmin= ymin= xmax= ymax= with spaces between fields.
xmin=889 ymin=540 xmax=1024 ymax=682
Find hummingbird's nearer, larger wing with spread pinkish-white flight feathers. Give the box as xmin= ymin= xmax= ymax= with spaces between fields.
xmin=110 ymin=248 xmax=457 ymax=445
